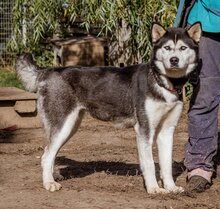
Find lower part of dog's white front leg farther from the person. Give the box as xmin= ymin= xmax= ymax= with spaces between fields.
xmin=135 ymin=123 xmax=166 ymax=194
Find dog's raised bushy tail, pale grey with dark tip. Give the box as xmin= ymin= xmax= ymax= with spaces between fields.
xmin=15 ymin=53 xmax=41 ymax=92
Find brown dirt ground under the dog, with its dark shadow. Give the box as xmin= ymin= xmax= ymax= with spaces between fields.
xmin=0 ymin=103 xmax=220 ymax=209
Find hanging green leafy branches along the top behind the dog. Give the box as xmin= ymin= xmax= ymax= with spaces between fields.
xmin=8 ymin=0 xmax=178 ymax=65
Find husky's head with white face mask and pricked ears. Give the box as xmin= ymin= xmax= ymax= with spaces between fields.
xmin=151 ymin=23 xmax=202 ymax=78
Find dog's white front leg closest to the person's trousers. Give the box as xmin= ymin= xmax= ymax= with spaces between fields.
xmin=157 ymin=102 xmax=183 ymax=193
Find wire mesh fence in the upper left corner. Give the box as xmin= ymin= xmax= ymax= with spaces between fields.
xmin=0 ymin=0 xmax=14 ymax=67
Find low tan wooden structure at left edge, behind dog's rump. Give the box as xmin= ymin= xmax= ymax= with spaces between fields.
xmin=0 ymin=87 xmax=41 ymax=129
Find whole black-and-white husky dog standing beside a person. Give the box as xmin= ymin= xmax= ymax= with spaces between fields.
xmin=16 ymin=23 xmax=201 ymax=194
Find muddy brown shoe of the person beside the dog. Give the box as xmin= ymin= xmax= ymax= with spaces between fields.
xmin=186 ymin=176 xmax=211 ymax=193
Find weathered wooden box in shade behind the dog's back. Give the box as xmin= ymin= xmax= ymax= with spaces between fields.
xmin=52 ymin=36 xmax=107 ymax=66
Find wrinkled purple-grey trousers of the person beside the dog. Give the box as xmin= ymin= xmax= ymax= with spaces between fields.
xmin=184 ymin=34 xmax=220 ymax=172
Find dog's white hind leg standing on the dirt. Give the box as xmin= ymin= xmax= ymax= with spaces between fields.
xmin=41 ymin=107 xmax=82 ymax=192
